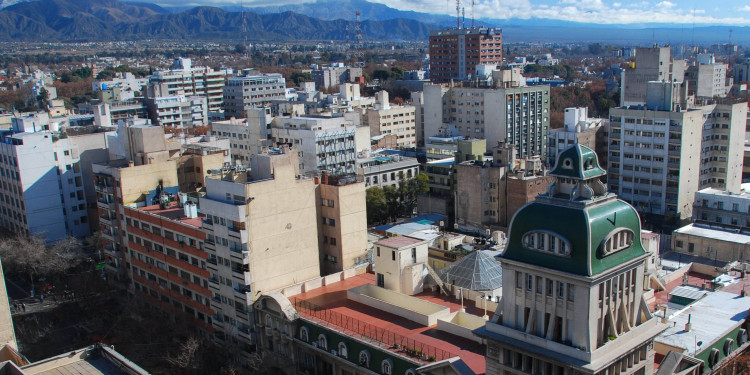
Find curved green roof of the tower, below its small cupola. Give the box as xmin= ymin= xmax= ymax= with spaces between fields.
xmin=502 ymin=198 xmax=646 ymax=276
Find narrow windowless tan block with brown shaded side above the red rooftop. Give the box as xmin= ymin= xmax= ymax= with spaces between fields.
xmin=316 ymin=177 xmax=367 ymax=275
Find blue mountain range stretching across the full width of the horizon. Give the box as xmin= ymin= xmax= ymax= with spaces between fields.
xmin=0 ymin=0 xmax=750 ymax=45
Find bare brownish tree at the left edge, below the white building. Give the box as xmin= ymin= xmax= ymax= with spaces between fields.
xmin=0 ymin=234 xmax=82 ymax=295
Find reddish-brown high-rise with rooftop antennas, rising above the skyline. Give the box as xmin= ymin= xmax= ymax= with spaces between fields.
xmin=429 ymin=27 xmax=503 ymax=82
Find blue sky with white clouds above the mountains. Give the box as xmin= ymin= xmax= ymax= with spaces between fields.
xmin=145 ymin=0 xmax=750 ymax=26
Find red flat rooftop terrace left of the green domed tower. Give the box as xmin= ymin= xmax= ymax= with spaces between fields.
xmin=290 ymin=273 xmax=490 ymax=374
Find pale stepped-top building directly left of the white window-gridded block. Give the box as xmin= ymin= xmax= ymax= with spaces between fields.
xmin=211 ymin=108 xmax=273 ymax=164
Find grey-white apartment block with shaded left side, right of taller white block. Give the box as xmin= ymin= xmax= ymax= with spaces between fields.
xmin=224 ymin=69 xmax=286 ymax=118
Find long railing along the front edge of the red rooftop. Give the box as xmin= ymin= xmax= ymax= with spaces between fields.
xmin=294 ymin=298 xmax=456 ymax=362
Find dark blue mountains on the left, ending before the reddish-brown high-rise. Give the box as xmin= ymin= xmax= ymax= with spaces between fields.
xmin=0 ymin=0 xmax=437 ymax=41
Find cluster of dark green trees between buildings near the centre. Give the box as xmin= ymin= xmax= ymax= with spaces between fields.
xmin=366 ymin=172 xmax=429 ymax=226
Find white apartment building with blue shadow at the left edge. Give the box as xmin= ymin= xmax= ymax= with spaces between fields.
xmin=0 ymin=121 xmax=107 ymax=242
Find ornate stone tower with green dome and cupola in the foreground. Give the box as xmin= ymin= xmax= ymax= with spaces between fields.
xmin=481 ymin=145 xmax=663 ymax=374
